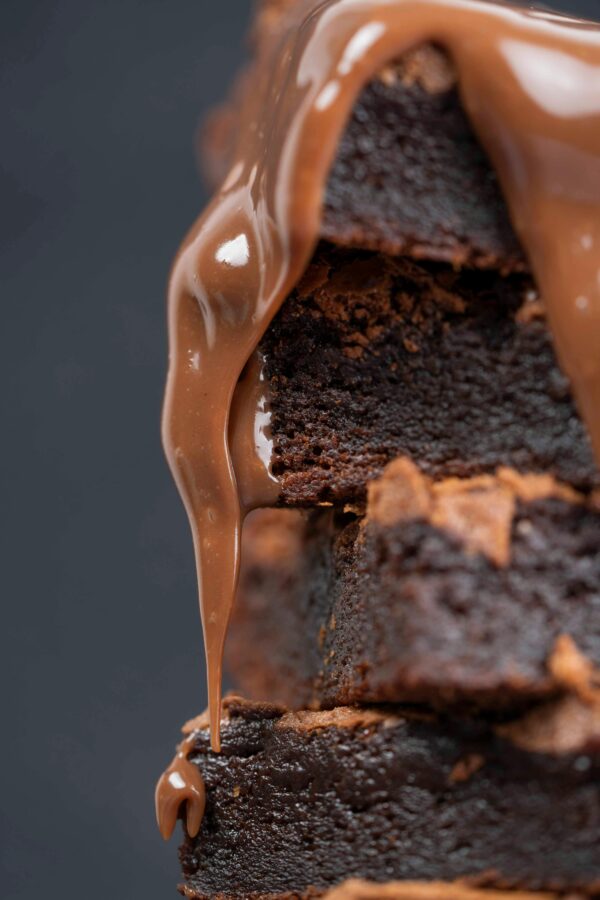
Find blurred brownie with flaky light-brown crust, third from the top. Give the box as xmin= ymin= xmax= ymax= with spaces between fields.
xmin=226 ymin=459 xmax=600 ymax=714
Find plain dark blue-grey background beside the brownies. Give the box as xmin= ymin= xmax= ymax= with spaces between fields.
xmin=0 ymin=0 xmax=600 ymax=900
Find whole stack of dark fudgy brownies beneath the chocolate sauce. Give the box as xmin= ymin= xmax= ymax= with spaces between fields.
xmin=170 ymin=0 xmax=600 ymax=900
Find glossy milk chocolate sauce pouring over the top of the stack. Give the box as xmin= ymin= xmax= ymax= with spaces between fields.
xmin=163 ymin=0 xmax=600 ymax=816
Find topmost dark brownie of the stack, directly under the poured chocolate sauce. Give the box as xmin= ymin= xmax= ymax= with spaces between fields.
xmin=202 ymin=32 xmax=526 ymax=271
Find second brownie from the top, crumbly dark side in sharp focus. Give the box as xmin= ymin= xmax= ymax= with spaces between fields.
xmin=255 ymin=245 xmax=600 ymax=505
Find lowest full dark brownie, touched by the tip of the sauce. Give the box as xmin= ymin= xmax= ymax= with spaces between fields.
xmin=180 ymin=699 xmax=600 ymax=898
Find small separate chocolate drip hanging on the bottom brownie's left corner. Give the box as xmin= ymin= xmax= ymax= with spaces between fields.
xmin=154 ymin=734 xmax=206 ymax=841
